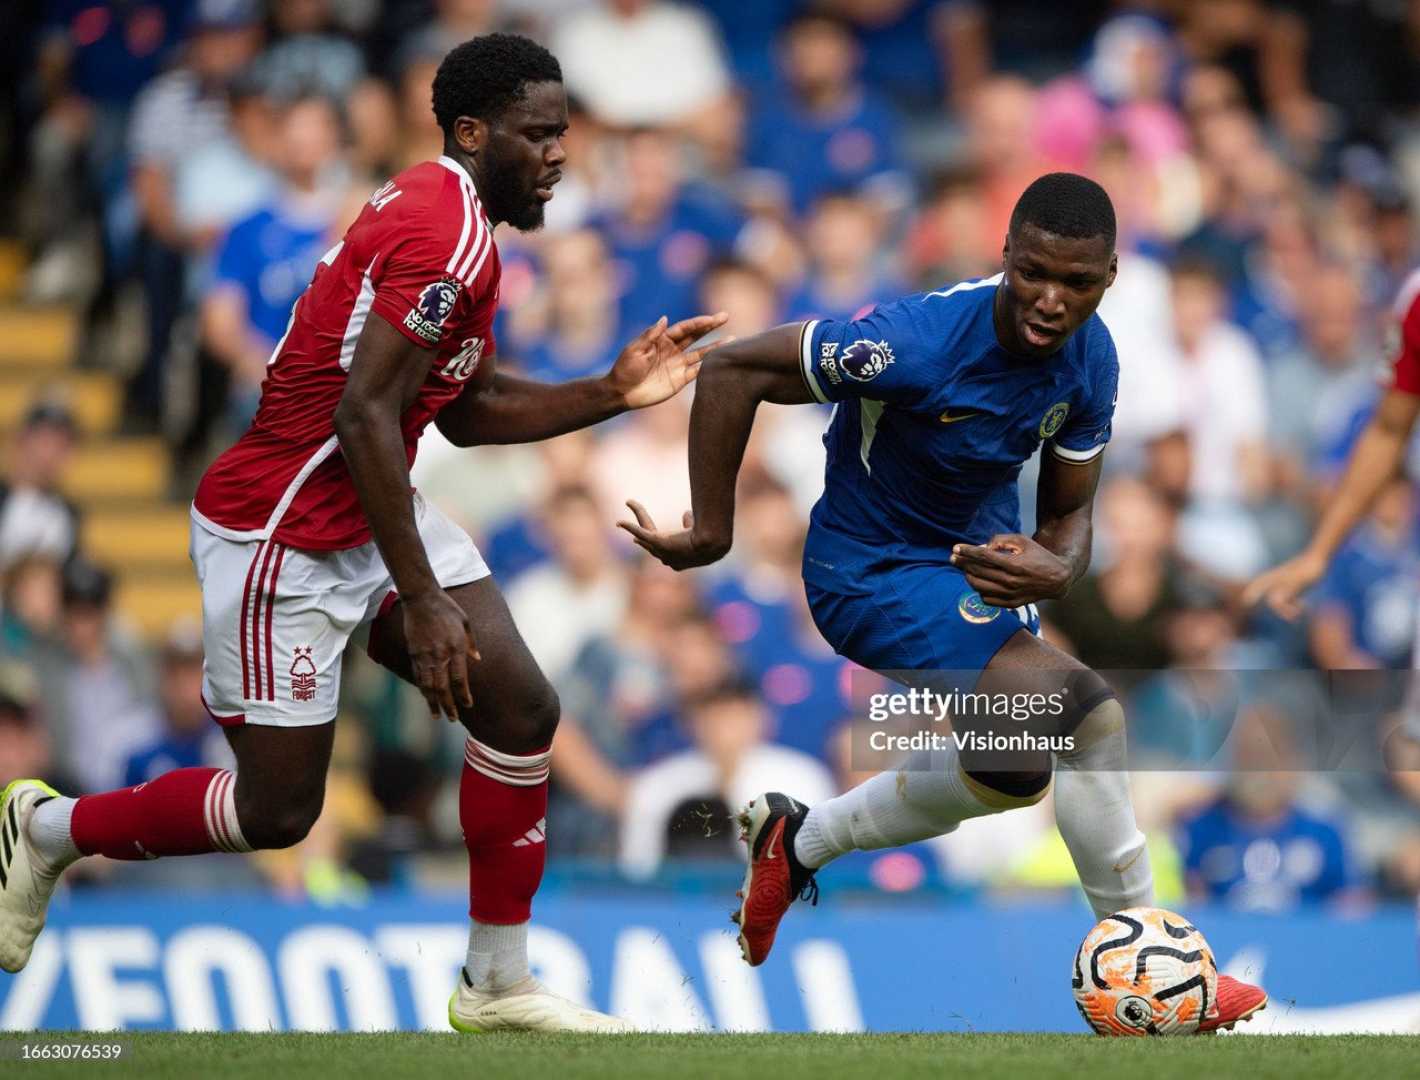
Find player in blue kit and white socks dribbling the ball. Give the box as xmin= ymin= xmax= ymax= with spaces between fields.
xmin=621 ymin=173 xmax=1267 ymax=1030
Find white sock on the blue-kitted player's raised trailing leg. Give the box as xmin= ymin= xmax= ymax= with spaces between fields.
xmin=794 ymin=745 xmax=1005 ymax=867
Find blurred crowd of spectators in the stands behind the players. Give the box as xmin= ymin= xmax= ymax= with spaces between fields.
xmin=0 ymin=0 xmax=1420 ymax=910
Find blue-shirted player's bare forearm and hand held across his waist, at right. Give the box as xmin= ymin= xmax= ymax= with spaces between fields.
xmin=951 ymin=451 xmax=1105 ymax=607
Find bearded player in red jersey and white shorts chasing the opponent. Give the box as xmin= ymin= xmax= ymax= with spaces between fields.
xmin=0 ymin=34 xmax=724 ymax=1032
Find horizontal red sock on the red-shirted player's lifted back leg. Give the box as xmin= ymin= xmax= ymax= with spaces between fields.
xmin=70 ymin=769 xmax=251 ymax=859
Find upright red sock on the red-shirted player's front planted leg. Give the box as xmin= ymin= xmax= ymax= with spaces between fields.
xmin=459 ymin=738 xmax=552 ymax=925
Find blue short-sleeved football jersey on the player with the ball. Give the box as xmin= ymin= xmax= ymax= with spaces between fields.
xmin=799 ymin=274 xmax=1119 ymax=593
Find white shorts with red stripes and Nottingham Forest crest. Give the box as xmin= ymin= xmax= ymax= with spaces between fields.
xmin=189 ymin=492 xmax=488 ymax=728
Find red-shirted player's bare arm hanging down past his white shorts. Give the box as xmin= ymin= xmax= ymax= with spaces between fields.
xmin=335 ymin=312 xmax=479 ymax=720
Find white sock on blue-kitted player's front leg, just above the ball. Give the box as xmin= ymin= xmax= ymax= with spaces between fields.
xmin=1055 ymin=698 xmax=1153 ymax=918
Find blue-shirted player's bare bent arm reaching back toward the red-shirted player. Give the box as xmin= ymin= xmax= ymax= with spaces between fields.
xmin=616 ymin=322 xmax=814 ymax=571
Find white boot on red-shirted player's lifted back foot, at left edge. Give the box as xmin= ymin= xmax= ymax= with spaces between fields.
xmin=0 ymin=781 xmax=62 ymax=972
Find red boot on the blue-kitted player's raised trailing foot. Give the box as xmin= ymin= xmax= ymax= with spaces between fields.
xmin=730 ymin=792 xmax=818 ymax=966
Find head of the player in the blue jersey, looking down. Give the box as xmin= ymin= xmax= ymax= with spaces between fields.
xmin=995 ymin=173 xmax=1118 ymax=358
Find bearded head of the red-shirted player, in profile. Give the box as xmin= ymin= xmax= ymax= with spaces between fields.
xmin=433 ymin=34 xmax=567 ymax=230
